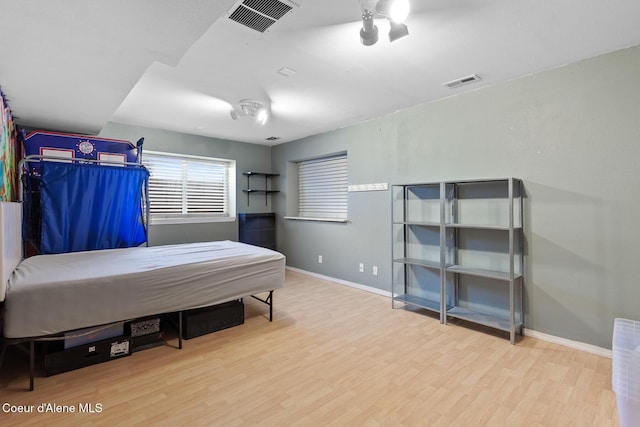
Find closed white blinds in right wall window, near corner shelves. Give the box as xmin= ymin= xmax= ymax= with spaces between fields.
xmin=298 ymin=154 xmax=348 ymax=220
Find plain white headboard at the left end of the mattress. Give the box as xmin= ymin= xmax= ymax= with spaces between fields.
xmin=0 ymin=202 xmax=22 ymax=301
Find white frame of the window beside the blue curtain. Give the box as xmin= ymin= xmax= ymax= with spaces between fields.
xmin=142 ymin=150 xmax=236 ymax=225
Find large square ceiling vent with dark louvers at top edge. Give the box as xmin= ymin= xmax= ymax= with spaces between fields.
xmin=229 ymin=0 xmax=293 ymax=33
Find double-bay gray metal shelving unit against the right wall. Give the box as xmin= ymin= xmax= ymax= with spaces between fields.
xmin=392 ymin=178 xmax=524 ymax=344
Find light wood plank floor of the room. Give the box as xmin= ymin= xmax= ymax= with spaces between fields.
xmin=0 ymin=272 xmax=618 ymax=427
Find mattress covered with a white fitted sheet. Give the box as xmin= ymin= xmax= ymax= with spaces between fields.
xmin=3 ymin=241 xmax=285 ymax=338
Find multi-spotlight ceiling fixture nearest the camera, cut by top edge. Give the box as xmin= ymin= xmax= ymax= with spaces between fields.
xmin=360 ymin=0 xmax=411 ymax=46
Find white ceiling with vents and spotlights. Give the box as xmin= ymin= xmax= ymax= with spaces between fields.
xmin=0 ymin=0 xmax=640 ymax=144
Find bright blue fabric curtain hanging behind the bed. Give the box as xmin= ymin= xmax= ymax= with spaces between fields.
xmin=40 ymin=162 xmax=149 ymax=254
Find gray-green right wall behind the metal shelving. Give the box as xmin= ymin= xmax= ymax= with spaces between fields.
xmin=271 ymin=47 xmax=640 ymax=348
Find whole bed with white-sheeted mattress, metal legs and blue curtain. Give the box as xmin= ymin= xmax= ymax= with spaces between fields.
xmin=0 ymin=134 xmax=285 ymax=390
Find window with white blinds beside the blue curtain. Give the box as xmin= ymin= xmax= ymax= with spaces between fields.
xmin=143 ymin=151 xmax=236 ymax=224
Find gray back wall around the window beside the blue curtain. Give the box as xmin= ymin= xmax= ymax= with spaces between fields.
xmin=100 ymin=123 xmax=272 ymax=246
